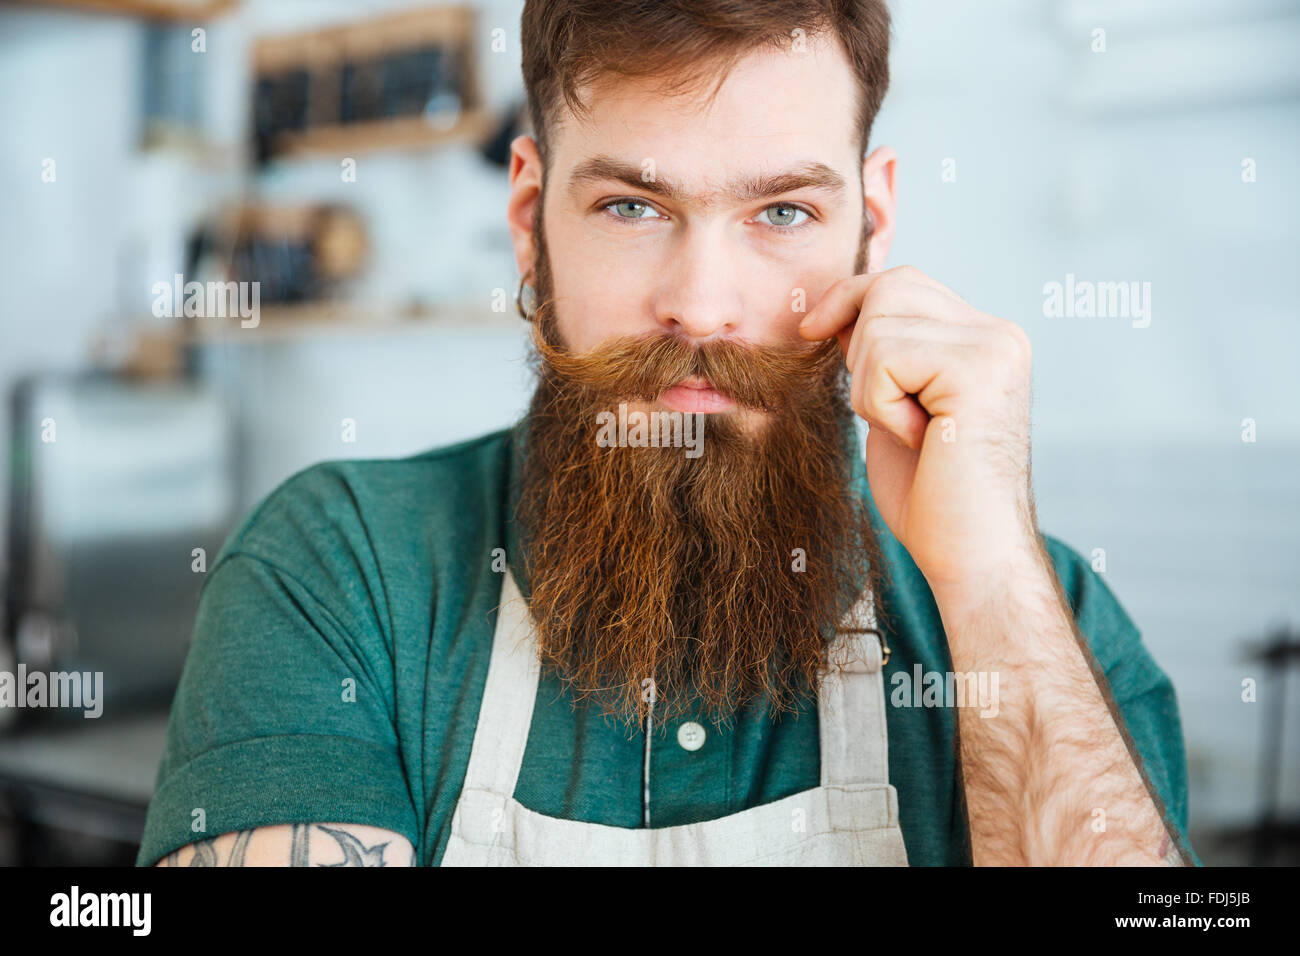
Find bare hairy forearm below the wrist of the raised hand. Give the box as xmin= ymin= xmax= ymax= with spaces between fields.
xmin=936 ymin=545 xmax=1183 ymax=866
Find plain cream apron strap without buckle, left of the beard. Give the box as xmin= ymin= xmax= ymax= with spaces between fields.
xmin=464 ymin=564 xmax=541 ymax=796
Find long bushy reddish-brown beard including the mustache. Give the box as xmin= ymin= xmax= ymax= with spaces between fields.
xmin=516 ymin=208 xmax=879 ymax=724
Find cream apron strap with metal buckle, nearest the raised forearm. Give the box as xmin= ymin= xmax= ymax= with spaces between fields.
xmin=818 ymin=588 xmax=889 ymax=787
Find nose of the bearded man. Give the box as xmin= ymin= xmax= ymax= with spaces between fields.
xmin=654 ymin=228 xmax=745 ymax=338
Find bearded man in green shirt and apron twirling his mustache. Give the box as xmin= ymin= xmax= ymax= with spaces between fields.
xmin=139 ymin=0 xmax=1195 ymax=865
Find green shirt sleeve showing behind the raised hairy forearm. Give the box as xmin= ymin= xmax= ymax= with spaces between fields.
xmin=1044 ymin=535 xmax=1203 ymax=866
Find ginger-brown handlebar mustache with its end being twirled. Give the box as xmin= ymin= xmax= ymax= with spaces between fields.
xmin=532 ymin=316 xmax=845 ymax=411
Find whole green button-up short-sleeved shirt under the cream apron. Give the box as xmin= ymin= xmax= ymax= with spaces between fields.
xmin=137 ymin=425 xmax=1199 ymax=865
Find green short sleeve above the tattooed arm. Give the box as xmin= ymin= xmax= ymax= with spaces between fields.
xmin=137 ymin=466 xmax=419 ymax=866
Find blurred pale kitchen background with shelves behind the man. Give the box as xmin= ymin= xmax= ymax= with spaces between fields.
xmin=0 ymin=0 xmax=1300 ymax=865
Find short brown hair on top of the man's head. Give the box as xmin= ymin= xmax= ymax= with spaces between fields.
xmin=521 ymin=0 xmax=889 ymax=168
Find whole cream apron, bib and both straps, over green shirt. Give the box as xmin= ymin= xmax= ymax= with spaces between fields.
xmin=442 ymin=568 xmax=907 ymax=866
